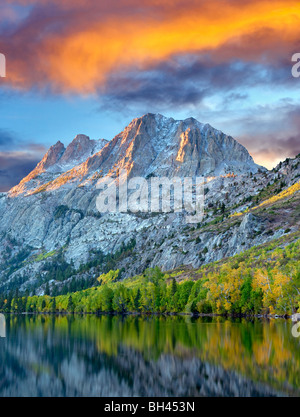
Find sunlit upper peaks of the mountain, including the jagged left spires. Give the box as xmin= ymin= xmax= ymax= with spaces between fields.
xmin=9 ymin=114 xmax=263 ymax=196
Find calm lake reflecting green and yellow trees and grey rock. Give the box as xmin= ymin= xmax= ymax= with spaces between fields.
xmin=0 ymin=315 xmax=300 ymax=397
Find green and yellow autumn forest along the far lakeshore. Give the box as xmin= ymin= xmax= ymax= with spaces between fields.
xmin=0 ymin=233 xmax=300 ymax=316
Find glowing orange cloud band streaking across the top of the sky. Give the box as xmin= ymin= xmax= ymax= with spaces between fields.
xmin=0 ymin=0 xmax=300 ymax=94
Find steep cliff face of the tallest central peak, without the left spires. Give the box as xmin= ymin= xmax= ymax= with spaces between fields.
xmin=85 ymin=114 xmax=259 ymax=177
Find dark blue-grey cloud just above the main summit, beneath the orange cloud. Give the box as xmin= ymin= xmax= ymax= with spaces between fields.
xmin=102 ymin=56 xmax=289 ymax=109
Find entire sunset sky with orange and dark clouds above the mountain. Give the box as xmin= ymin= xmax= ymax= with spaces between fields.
xmin=0 ymin=0 xmax=300 ymax=191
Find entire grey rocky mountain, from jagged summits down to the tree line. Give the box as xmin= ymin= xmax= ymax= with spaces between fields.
xmin=0 ymin=114 xmax=300 ymax=293
